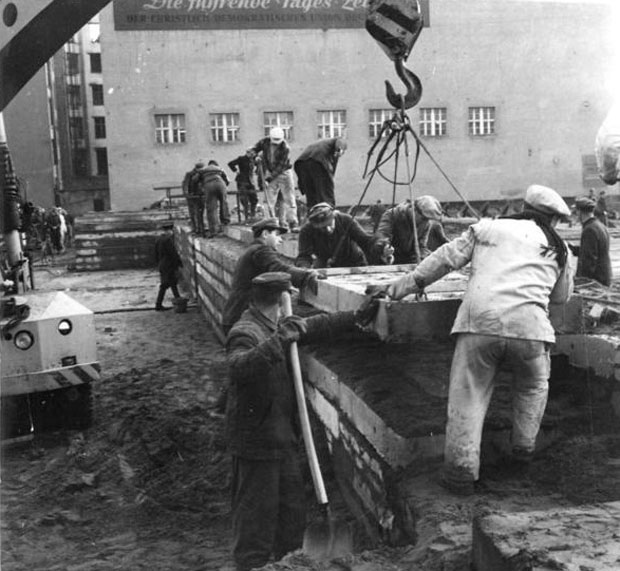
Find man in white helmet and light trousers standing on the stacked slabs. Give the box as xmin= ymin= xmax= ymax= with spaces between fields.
xmin=252 ymin=127 xmax=299 ymax=232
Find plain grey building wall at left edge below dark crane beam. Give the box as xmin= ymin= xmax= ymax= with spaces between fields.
xmin=3 ymin=69 xmax=54 ymax=207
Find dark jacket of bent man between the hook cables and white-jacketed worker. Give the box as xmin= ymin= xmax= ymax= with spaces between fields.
xmin=377 ymin=204 xmax=448 ymax=264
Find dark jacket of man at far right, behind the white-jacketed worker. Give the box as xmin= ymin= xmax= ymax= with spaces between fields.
xmin=577 ymin=217 xmax=611 ymax=286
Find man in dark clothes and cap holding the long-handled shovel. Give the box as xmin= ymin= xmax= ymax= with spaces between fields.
xmin=226 ymin=272 xmax=378 ymax=571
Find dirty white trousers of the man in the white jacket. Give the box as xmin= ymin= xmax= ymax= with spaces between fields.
xmin=444 ymin=333 xmax=551 ymax=481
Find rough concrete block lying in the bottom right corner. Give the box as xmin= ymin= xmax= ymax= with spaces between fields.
xmin=472 ymin=502 xmax=620 ymax=571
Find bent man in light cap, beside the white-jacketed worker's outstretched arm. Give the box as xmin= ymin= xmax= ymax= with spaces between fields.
xmin=377 ymin=195 xmax=448 ymax=264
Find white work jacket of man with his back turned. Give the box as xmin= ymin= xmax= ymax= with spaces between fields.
xmin=394 ymin=218 xmax=575 ymax=343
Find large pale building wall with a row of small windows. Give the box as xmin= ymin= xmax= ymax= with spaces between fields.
xmin=101 ymin=0 xmax=613 ymax=210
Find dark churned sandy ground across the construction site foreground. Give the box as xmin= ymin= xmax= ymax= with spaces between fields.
xmin=0 ymin=258 xmax=620 ymax=571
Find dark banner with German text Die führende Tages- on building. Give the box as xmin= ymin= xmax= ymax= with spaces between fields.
xmin=114 ymin=0 xmax=429 ymax=30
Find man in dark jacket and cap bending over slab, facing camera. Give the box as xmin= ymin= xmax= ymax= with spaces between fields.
xmin=295 ymin=202 xmax=393 ymax=268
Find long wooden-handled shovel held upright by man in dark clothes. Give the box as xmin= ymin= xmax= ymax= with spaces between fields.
xmin=282 ymin=292 xmax=353 ymax=560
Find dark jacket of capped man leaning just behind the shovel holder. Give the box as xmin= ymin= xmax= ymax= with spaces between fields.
xmin=222 ymin=238 xmax=310 ymax=333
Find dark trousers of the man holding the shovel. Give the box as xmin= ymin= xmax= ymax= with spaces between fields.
xmin=232 ymin=450 xmax=306 ymax=571
